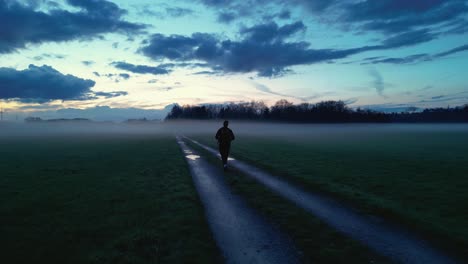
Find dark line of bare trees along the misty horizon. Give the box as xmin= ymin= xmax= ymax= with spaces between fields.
xmin=166 ymin=99 xmax=468 ymax=123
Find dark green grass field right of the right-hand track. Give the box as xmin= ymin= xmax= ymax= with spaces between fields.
xmin=189 ymin=127 xmax=468 ymax=257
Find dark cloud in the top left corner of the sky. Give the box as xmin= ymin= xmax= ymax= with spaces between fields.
xmin=0 ymin=0 xmax=144 ymax=53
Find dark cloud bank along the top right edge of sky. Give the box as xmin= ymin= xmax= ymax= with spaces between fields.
xmin=199 ymin=0 xmax=468 ymax=45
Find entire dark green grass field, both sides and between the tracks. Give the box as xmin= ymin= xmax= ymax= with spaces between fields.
xmin=0 ymin=122 xmax=468 ymax=263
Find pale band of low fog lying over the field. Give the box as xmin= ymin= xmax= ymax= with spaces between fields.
xmin=0 ymin=120 xmax=468 ymax=139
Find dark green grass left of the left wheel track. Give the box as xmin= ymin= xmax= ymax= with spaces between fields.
xmin=0 ymin=135 xmax=220 ymax=263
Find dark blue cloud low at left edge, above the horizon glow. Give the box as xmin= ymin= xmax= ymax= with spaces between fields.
xmin=0 ymin=64 xmax=95 ymax=102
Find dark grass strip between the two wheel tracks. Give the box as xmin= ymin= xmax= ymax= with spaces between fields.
xmin=188 ymin=139 xmax=391 ymax=263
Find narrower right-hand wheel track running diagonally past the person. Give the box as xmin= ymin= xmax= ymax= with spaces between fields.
xmin=189 ymin=139 xmax=456 ymax=264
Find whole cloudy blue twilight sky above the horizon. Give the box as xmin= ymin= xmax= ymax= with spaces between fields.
xmin=0 ymin=0 xmax=468 ymax=120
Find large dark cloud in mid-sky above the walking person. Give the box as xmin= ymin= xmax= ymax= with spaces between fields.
xmin=140 ymin=21 xmax=431 ymax=77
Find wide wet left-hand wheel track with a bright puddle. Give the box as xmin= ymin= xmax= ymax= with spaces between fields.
xmin=177 ymin=138 xmax=299 ymax=263
